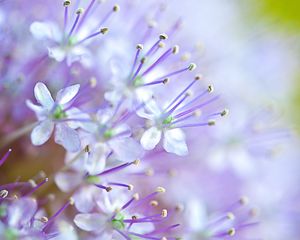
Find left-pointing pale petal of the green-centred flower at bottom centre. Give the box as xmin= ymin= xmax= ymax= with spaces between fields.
xmin=74 ymin=213 xmax=108 ymax=232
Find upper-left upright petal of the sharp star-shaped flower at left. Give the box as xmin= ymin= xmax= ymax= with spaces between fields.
xmin=34 ymin=82 xmax=54 ymax=110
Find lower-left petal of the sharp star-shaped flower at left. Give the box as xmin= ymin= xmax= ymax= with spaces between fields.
xmin=31 ymin=120 xmax=54 ymax=146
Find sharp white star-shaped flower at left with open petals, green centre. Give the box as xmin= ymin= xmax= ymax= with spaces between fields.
xmin=26 ymin=82 xmax=82 ymax=152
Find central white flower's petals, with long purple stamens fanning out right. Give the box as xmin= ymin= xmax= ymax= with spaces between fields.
xmin=137 ymin=100 xmax=188 ymax=156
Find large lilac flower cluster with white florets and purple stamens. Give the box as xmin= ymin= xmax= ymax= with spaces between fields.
xmin=0 ymin=0 xmax=298 ymax=240
